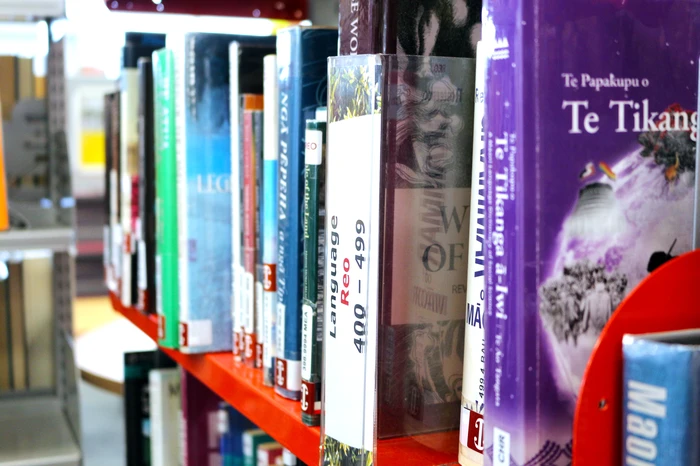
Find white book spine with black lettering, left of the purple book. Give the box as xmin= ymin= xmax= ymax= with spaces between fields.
xmin=459 ymin=43 xmax=486 ymax=466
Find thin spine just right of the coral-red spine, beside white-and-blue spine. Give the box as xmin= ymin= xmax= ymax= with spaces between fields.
xmin=253 ymin=110 xmax=265 ymax=368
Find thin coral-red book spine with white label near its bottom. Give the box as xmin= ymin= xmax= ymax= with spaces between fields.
xmin=243 ymin=110 xmax=257 ymax=367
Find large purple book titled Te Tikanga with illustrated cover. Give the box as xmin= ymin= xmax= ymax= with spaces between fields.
xmin=483 ymin=0 xmax=700 ymax=466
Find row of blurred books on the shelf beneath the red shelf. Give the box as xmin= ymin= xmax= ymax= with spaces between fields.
xmin=124 ymin=350 xmax=303 ymax=466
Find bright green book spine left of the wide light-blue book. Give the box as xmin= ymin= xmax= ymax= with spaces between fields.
xmin=153 ymin=49 xmax=180 ymax=348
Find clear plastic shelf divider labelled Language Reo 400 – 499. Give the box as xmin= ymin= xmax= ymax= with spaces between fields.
xmin=323 ymin=55 xmax=475 ymax=464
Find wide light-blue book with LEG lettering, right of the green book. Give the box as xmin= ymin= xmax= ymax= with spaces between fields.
xmin=168 ymin=33 xmax=234 ymax=353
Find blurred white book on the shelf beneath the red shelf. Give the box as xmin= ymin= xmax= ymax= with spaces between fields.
xmin=148 ymin=368 xmax=180 ymax=466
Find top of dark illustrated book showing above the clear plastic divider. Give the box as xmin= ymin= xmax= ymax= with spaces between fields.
xmin=339 ymin=0 xmax=482 ymax=58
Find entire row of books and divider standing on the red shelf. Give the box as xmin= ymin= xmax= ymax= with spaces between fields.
xmin=101 ymin=0 xmax=700 ymax=465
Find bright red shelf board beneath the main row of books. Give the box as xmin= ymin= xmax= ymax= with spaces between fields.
xmin=110 ymin=292 xmax=459 ymax=466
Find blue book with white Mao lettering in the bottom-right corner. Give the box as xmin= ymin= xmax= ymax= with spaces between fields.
xmin=622 ymin=330 xmax=700 ymax=466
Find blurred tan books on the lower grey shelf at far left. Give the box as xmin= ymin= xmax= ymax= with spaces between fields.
xmin=0 ymin=252 xmax=55 ymax=393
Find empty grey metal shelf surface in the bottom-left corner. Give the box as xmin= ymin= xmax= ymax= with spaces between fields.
xmin=0 ymin=397 xmax=81 ymax=466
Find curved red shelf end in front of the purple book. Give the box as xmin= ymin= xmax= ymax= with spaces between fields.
xmin=573 ymin=250 xmax=700 ymax=466
